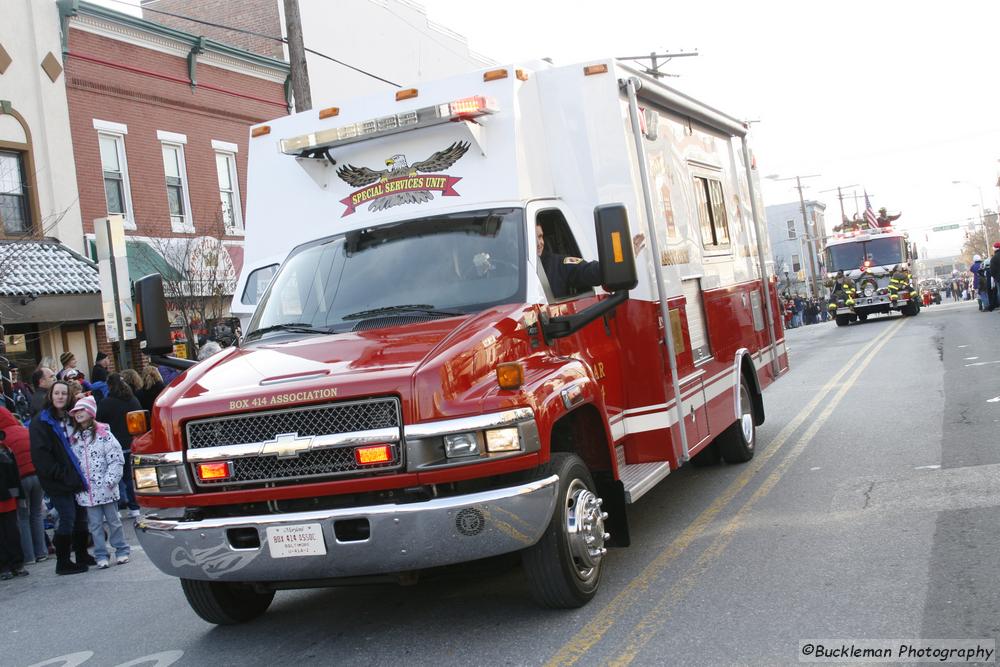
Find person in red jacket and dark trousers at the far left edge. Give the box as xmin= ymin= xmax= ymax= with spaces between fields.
xmin=0 ymin=408 xmax=49 ymax=563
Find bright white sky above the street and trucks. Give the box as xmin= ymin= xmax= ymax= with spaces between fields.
xmin=412 ymin=0 xmax=1000 ymax=257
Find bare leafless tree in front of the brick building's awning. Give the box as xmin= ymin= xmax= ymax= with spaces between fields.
xmin=149 ymin=215 xmax=236 ymax=359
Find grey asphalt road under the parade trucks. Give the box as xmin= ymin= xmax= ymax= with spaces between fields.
xmin=0 ymin=303 xmax=1000 ymax=667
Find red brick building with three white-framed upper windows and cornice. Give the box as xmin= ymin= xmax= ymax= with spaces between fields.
xmin=58 ymin=0 xmax=288 ymax=362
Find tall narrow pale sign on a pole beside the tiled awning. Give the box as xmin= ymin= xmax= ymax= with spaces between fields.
xmin=94 ymin=215 xmax=135 ymax=343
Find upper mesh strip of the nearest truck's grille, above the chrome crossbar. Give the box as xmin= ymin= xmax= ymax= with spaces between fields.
xmin=187 ymin=398 xmax=400 ymax=449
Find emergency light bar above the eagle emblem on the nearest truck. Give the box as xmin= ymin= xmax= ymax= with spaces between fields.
xmin=280 ymin=95 xmax=498 ymax=155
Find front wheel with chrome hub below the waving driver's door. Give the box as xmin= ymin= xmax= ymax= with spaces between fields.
xmin=521 ymin=452 xmax=610 ymax=609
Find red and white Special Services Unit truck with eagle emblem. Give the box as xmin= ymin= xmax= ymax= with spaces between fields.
xmin=133 ymin=60 xmax=787 ymax=624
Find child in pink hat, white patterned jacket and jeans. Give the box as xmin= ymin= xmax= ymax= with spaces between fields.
xmin=69 ymin=396 xmax=131 ymax=570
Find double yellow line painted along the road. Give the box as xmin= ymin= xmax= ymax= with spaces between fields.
xmin=546 ymin=319 xmax=906 ymax=666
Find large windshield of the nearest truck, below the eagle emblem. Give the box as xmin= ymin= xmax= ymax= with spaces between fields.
xmin=247 ymin=208 xmax=526 ymax=339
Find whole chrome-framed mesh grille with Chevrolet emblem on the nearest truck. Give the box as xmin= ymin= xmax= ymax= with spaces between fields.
xmin=186 ymin=398 xmax=402 ymax=487
